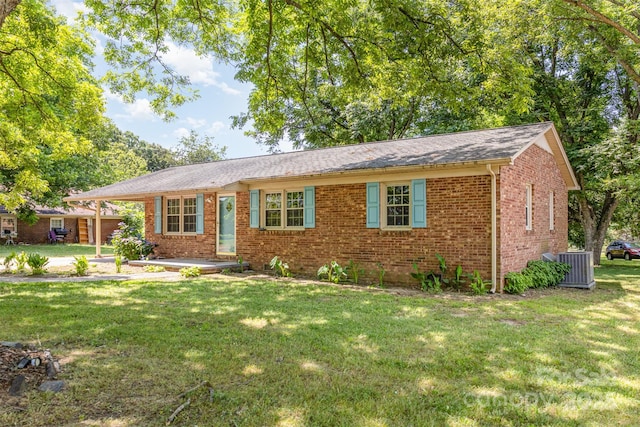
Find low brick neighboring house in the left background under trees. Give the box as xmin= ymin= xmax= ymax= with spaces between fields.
xmin=0 ymin=204 xmax=122 ymax=244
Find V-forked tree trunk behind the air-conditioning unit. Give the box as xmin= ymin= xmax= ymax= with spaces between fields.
xmin=578 ymin=191 xmax=620 ymax=265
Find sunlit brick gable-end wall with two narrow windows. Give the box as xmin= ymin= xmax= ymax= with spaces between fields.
xmin=499 ymin=146 xmax=568 ymax=283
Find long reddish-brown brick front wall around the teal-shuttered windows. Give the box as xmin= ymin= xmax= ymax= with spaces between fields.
xmin=145 ymin=176 xmax=491 ymax=284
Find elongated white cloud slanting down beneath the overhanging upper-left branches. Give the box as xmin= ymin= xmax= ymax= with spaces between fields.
xmin=162 ymin=43 xmax=241 ymax=95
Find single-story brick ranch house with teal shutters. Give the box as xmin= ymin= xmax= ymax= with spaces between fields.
xmin=67 ymin=123 xmax=578 ymax=289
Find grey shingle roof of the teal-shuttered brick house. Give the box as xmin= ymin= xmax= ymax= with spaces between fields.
xmin=67 ymin=122 xmax=564 ymax=200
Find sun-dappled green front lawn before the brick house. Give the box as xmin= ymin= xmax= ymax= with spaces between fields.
xmin=0 ymin=261 xmax=640 ymax=427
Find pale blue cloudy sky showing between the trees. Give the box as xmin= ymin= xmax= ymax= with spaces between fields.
xmin=50 ymin=0 xmax=292 ymax=158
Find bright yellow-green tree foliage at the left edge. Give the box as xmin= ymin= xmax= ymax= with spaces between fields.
xmin=0 ymin=0 xmax=104 ymax=210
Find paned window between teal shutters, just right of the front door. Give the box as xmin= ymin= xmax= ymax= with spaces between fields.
xmin=264 ymin=190 xmax=304 ymax=228
